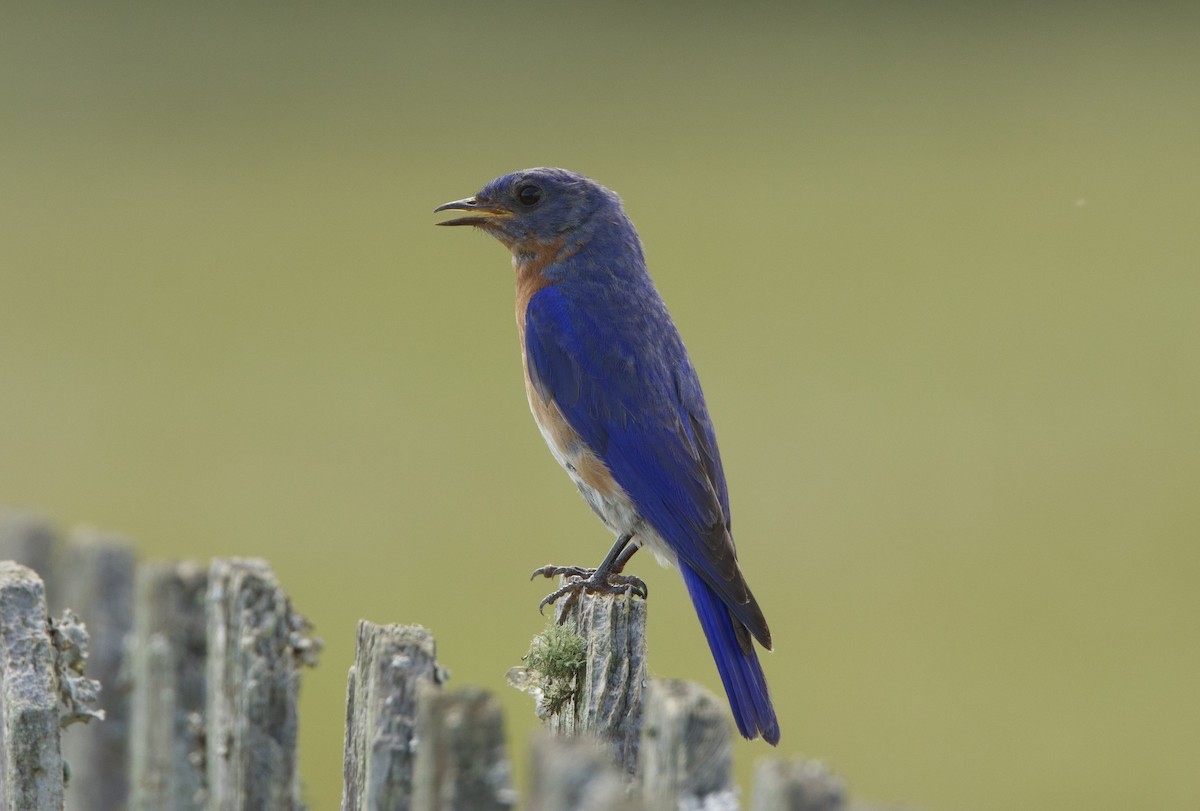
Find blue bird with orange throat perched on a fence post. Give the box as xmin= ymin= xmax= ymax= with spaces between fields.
xmin=434 ymin=167 xmax=780 ymax=745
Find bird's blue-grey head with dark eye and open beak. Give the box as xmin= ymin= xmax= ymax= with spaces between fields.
xmin=434 ymin=168 xmax=620 ymax=253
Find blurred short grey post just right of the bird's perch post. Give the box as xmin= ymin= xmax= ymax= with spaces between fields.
xmin=638 ymin=679 xmax=740 ymax=811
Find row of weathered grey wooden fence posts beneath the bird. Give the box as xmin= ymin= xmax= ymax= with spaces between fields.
xmin=0 ymin=512 xmax=883 ymax=811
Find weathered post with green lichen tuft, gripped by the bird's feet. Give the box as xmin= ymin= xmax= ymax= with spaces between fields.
xmin=509 ymin=583 xmax=647 ymax=775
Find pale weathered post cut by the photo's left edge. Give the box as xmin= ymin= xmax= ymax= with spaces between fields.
xmin=0 ymin=560 xmax=62 ymax=811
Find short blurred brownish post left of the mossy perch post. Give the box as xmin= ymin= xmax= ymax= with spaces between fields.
xmin=410 ymin=686 xmax=517 ymax=811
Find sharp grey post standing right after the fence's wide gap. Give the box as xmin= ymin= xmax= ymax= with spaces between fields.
xmin=342 ymin=620 xmax=446 ymax=811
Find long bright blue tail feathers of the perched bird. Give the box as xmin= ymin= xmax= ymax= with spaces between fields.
xmin=679 ymin=563 xmax=779 ymax=746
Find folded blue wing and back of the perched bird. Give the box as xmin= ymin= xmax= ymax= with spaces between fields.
xmin=526 ymin=286 xmax=770 ymax=647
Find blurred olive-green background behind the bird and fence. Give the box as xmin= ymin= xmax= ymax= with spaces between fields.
xmin=0 ymin=2 xmax=1200 ymax=811
